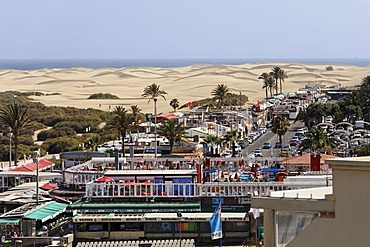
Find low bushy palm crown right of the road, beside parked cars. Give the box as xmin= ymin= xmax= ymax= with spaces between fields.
xmin=299 ymin=128 xmax=336 ymax=151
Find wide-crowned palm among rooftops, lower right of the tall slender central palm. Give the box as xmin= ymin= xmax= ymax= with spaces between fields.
xmin=158 ymin=119 xmax=185 ymax=154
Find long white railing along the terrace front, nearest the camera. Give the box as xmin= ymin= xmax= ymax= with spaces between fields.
xmin=85 ymin=180 xmax=331 ymax=198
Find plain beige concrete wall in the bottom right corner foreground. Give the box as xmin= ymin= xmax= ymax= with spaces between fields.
xmin=287 ymin=157 xmax=370 ymax=247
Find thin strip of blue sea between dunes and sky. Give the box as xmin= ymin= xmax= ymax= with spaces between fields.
xmin=0 ymin=58 xmax=370 ymax=70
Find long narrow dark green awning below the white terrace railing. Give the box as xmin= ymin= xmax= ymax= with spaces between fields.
xmin=68 ymin=202 xmax=201 ymax=213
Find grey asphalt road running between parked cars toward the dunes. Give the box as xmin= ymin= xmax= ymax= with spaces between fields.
xmin=242 ymin=121 xmax=304 ymax=157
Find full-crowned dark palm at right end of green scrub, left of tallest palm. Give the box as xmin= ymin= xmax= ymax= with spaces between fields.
xmin=108 ymin=106 xmax=134 ymax=157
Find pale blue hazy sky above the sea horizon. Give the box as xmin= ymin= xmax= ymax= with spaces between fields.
xmin=0 ymin=0 xmax=370 ymax=58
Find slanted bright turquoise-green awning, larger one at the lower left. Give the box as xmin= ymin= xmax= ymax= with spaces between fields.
xmin=24 ymin=202 xmax=68 ymax=222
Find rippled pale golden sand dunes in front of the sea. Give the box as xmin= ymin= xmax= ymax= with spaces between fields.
xmin=0 ymin=63 xmax=370 ymax=113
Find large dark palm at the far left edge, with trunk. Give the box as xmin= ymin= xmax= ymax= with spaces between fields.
xmin=0 ymin=102 xmax=33 ymax=166
